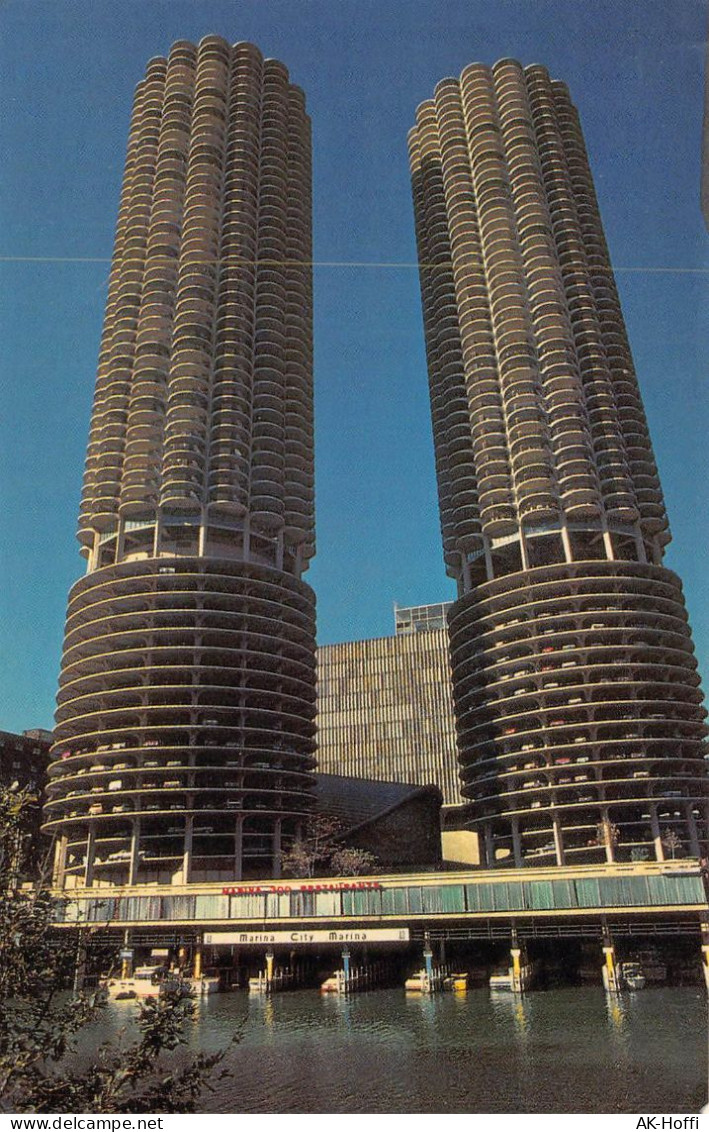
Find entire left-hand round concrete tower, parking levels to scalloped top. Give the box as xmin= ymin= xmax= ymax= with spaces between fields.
xmin=45 ymin=36 xmax=315 ymax=886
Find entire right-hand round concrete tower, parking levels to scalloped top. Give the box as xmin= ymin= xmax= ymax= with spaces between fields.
xmin=409 ymin=60 xmax=708 ymax=865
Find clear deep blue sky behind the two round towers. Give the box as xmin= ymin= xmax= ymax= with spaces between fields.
xmin=0 ymin=0 xmax=709 ymax=730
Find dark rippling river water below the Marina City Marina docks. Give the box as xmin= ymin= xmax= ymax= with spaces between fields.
xmin=93 ymin=986 xmax=707 ymax=1114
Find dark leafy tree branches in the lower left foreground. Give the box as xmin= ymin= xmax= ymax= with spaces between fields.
xmin=0 ymin=788 xmax=236 ymax=1113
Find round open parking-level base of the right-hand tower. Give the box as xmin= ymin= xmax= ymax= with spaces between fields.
xmin=450 ymin=561 xmax=709 ymax=864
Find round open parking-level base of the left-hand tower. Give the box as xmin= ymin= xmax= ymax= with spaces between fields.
xmin=45 ymin=558 xmax=315 ymax=884
